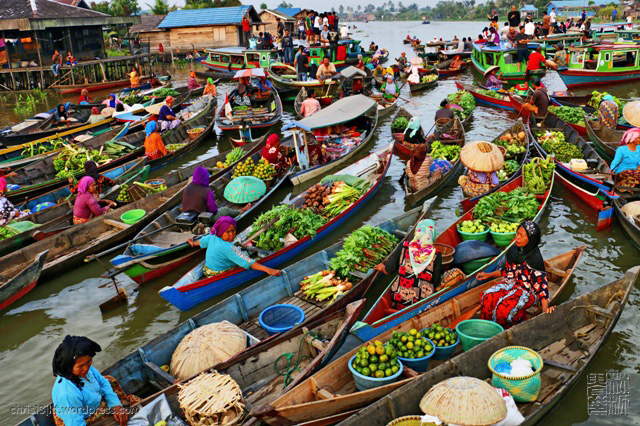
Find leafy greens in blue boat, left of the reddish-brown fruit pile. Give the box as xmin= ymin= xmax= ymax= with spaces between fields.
xmin=250 ymin=205 xmax=327 ymax=251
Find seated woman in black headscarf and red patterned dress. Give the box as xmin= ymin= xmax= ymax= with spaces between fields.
xmin=477 ymin=222 xmax=555 ymax=327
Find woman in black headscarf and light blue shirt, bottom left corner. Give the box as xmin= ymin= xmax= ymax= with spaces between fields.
xmin=51 ymin=336 xmax=140 ymax=426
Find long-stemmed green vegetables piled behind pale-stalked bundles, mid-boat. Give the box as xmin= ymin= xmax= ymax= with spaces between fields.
xmin=331 ymin=225 xmax=398 ymax=278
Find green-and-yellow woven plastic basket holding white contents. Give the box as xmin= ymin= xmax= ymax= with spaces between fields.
xmin=488 ymin=346 xmax=544 ymax=402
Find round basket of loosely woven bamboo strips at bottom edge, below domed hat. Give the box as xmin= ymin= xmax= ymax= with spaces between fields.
xmin=178 ymin=371 xmax=244 ymax=426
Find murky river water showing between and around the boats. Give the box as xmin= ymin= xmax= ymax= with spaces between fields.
xmin=0 ymin=22 xmax=640 ymax=425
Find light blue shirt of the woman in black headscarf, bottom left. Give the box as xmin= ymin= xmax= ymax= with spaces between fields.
xmin=51 ymin=367 xmax=122 ymax=426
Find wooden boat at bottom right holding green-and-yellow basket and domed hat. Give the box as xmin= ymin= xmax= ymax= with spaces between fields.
xmin=336 ymin=266 xmax=640 ymax=426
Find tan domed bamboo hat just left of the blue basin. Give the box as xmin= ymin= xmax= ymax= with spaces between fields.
xmin=171 ymin=321 xmax=247 ymax=380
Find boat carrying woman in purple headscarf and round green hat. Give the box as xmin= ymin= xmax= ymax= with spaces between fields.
xmin=111 ymin=139 xmax=291 ymax=283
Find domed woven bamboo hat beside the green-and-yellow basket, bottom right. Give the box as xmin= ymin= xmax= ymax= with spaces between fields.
xmin=420 ymin=377 xmax=507 ymax=426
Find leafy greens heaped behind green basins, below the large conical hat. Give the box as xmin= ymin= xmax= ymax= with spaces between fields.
xmin=473 ymin=188 xmax=539 ymax=223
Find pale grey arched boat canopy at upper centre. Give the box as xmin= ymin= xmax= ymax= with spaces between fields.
xmin=284 ymin=95 xmax=378 ymax=131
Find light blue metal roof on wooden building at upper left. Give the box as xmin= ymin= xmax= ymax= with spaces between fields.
xmin=158 ymin=6 xmax=252 ymax=28
